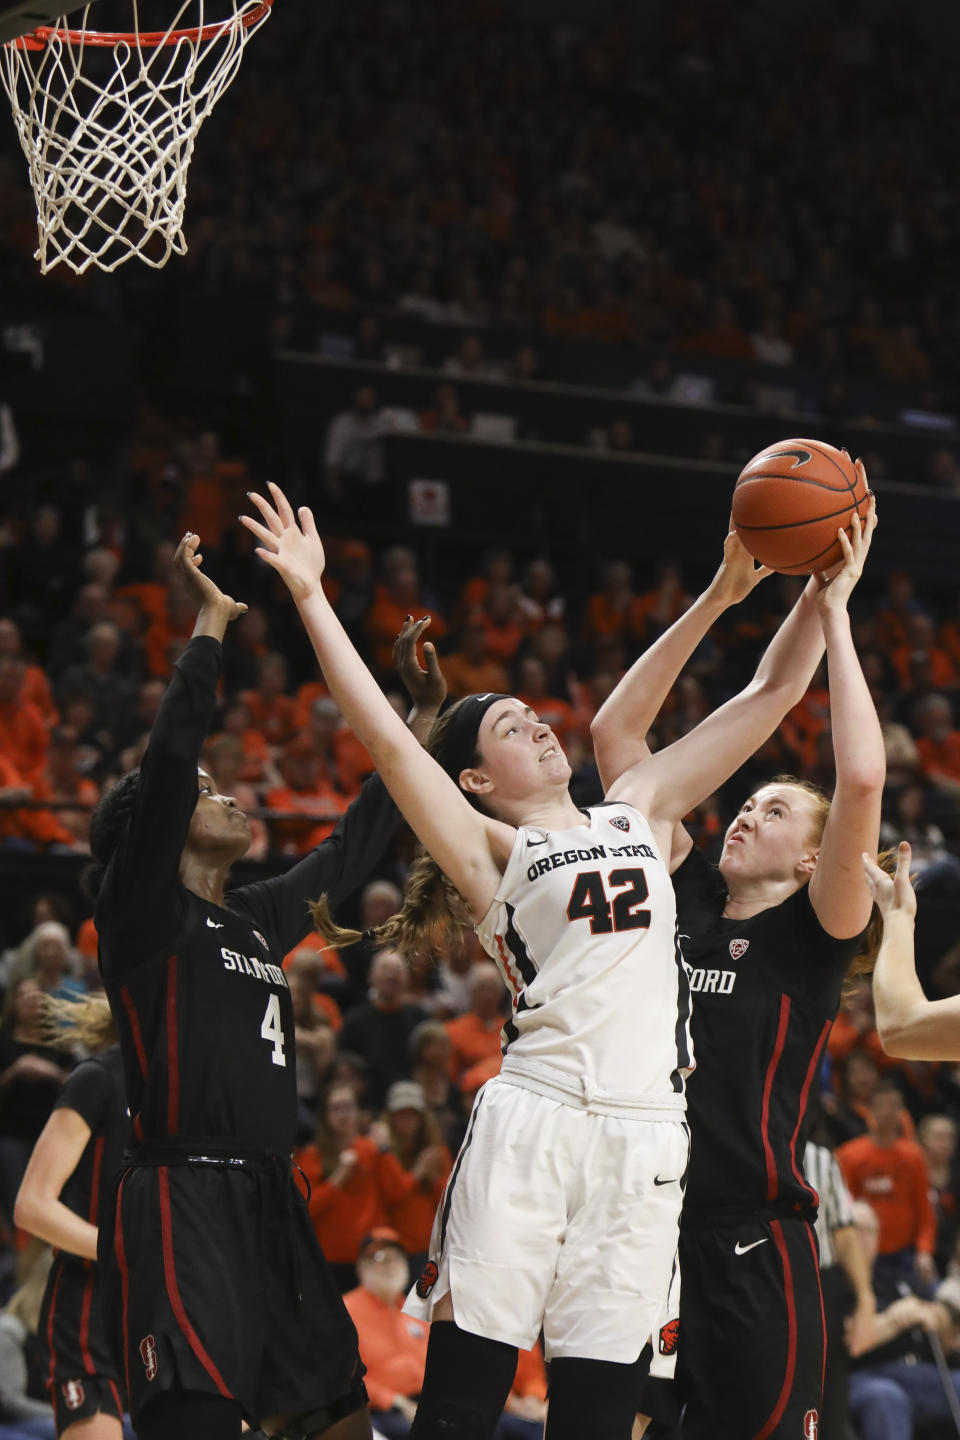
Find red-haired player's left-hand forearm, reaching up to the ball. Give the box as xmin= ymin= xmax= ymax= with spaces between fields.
xmin=590 ymin=530 xmax=782 ymax=791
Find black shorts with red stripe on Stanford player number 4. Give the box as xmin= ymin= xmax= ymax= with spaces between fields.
xmin=101 ymin=1156 xmax=366 ymax=1423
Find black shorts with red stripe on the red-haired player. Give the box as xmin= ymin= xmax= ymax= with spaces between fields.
xmin=676 ymin=1218 xmax=826 ymax=1440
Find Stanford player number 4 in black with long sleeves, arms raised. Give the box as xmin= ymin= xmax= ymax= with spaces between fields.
xmin=91 ymin=534 xmax=443 ymax=1440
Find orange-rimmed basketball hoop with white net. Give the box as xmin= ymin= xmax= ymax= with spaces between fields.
xmin=0 ymin=0 xmax=273 ymax=275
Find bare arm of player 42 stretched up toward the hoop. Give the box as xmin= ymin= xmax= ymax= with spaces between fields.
xmin=242 ymin=484 xmax=515 ymax=917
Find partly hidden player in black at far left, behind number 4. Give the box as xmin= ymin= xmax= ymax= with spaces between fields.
xmin=14 ymin=995 xmax=130 ymax=1440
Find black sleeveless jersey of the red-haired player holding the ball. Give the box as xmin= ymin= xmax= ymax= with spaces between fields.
xmin=672 ymin=848 xmax=861 ymax=1224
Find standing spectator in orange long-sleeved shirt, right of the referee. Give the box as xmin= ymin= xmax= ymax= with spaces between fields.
xmin=836 ymin=1080 xmax=937 ymax=1290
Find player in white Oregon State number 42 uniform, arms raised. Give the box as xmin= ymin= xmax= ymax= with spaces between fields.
xmin=243 ymin=485 xmax=820 ymax=1440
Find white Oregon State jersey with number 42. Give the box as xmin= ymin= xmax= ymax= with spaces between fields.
xmin=476 ymin=802 xmax=694 ymax=1119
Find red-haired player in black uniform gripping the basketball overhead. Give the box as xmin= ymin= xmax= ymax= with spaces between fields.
xmin=594 ymin=504 xmax=885 ymax=1440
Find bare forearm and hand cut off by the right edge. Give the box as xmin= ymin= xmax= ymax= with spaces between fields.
xmin=862 ymin=841 xmax=960 ymax=1060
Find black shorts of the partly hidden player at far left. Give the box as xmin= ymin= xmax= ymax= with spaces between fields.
xmin=37 ymin=1253 xmax=124 ymax=1436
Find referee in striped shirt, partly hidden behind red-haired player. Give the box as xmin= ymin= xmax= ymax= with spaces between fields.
xmin=803 ymin=1142 xmax=877 ymax=1440
